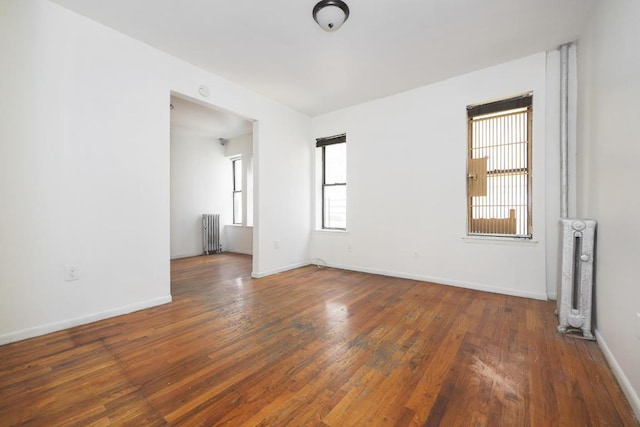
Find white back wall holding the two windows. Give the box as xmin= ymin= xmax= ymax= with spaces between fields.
xmin=309 ymin=53 xmax=558 ymax=299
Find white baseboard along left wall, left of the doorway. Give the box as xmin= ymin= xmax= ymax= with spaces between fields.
xmin=0 ymin=295 xmax=172 ymax=345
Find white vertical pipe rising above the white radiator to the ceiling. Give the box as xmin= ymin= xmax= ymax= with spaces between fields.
xmin=559 ymin=43 xmax=572 ymax=218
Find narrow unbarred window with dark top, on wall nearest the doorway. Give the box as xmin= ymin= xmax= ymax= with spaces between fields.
xmin=316 ymin=134 xmax=347 ymax=230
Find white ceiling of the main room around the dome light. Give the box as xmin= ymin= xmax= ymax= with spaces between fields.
xmin=53 ymin=0 xmax=595 ymax=116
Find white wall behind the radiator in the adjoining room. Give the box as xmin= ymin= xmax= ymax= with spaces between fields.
xmin=171 ymin=127 xmax=233 ymax=258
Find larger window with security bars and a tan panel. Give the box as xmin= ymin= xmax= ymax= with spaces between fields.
xmin=467 ymin=94 xmax=532 ymax=238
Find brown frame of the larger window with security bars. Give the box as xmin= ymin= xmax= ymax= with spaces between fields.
xmin=466 ymin=92 xmax=533 ymax=240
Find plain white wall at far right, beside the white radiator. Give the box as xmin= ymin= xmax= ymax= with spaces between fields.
xmin=578 ymin=0 xmax=640 ymax=417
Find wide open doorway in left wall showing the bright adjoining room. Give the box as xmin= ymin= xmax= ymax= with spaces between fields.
xmin=170 ymin=93 xmax=253 ymax=259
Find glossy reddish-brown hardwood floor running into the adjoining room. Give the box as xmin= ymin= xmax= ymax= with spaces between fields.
xmin=0 ymin=254 xmax=638 ymax=426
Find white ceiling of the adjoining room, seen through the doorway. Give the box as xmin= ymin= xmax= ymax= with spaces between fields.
xmin=171 ymin=95 xmax=253 ymax=139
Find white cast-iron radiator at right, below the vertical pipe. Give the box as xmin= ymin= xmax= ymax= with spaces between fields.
xmin=557 ymin=219 xmax=596 ymax=339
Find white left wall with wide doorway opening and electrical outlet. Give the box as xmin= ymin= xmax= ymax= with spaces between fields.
xmin=0 ymin=0 xmax=311 ymax=343
